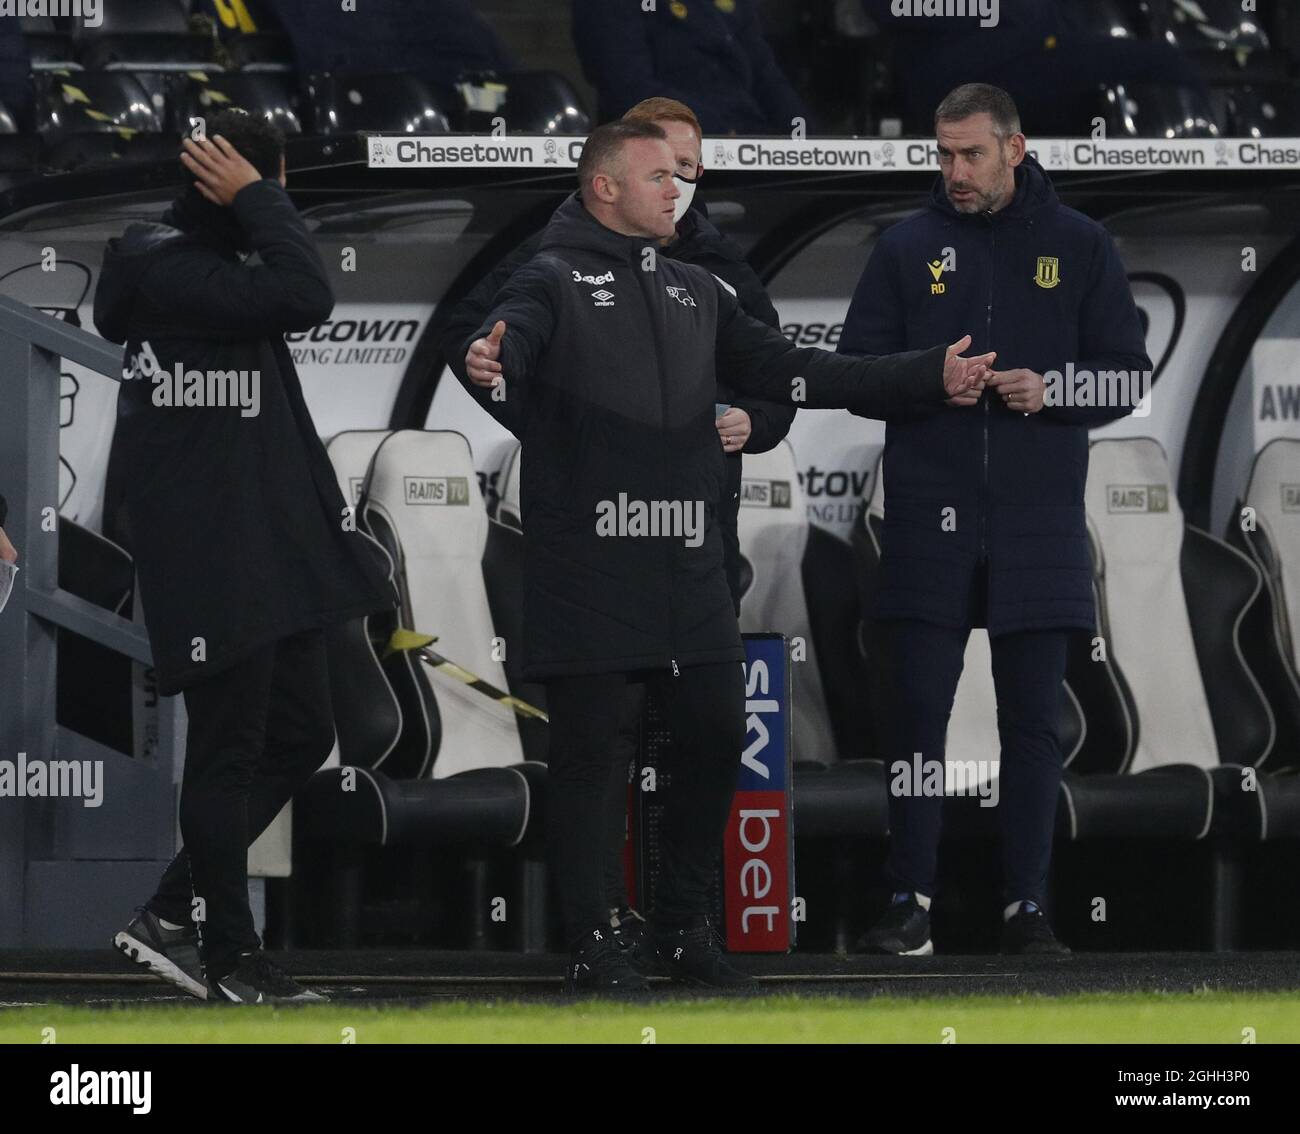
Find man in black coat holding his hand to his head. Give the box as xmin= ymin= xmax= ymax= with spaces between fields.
xmin=95 ymin=112 xmax=394 ymax=1001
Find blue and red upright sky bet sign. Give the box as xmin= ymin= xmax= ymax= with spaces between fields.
xmin=723 ymin=635 xmax=794 ymax=953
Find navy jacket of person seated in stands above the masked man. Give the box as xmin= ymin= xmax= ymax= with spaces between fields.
xmin=573 ymin=0 xmax=807 ymax=135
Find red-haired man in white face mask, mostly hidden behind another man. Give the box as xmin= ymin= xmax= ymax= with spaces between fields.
xmin=442 ymin=98 xmax=796 ymax=967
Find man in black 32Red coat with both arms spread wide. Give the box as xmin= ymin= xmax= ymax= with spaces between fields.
xmin=465 ymin=122 xmax=992 ymax=988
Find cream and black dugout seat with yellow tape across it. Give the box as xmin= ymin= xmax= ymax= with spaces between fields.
xmin=298 ymin=429 xmax=546 ymax=951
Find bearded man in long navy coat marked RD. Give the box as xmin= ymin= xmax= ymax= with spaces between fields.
xmin=840 ymin=83 xmax=1151 ymax=955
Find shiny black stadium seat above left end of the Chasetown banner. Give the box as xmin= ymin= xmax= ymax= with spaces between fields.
xmin=306 ymin=72 xmax=451 ymax=134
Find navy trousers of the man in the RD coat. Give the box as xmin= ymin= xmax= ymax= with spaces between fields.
xmin=880 ymin=620 xmax=1067 ymax=904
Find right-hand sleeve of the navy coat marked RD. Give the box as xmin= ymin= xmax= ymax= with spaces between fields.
xmin=1041 ymin=231 xmax=1152 ymax=428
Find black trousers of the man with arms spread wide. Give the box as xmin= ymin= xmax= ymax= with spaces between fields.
xmin=546 ymin=662 xmax=745 ymax=943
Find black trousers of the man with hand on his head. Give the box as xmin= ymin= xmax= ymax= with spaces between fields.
xmin=148 ymin=629 xmax=334 ymax=978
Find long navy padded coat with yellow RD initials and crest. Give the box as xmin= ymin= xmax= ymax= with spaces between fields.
xmin=839 ymin=156 xmax=1152 ymax=635
